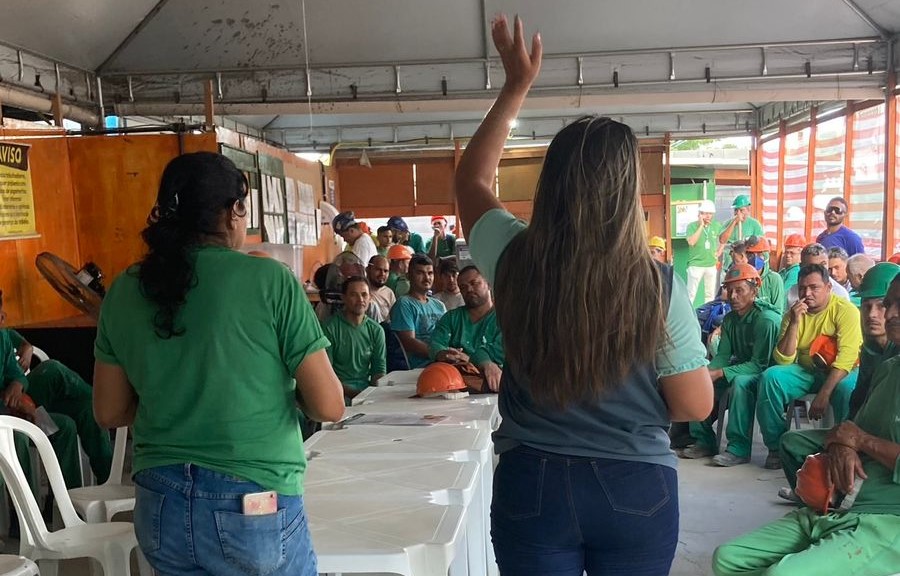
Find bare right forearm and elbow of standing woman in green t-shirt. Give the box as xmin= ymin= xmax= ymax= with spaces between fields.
xmin=294 ymin=350 xmax=344 ymax=422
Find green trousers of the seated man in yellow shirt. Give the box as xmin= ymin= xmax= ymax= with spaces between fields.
xmin=756 ymin=364 xmax=857 ymax=451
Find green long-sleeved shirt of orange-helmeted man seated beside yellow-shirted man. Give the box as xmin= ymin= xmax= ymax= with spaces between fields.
xmin=709 ymin=299 xmax=781 ymax=382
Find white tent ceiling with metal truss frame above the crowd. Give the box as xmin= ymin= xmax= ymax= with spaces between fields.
xmin=0 ymin=0 xmax=900 ymax=149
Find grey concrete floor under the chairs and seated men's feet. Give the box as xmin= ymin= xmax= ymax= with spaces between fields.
xmin=3 ymin=423 xmax=808 ymax=576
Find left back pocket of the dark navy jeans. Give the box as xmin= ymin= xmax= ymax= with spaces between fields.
xmin=491 ymin=450 xmax=547 ymax=520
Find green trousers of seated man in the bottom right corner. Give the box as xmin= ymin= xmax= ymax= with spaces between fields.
xmin=713 ymin=508 xmax=900 ymax=576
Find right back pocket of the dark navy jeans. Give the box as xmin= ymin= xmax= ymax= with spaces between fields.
xmin=591 ymin=460 xmax=671 ymax=516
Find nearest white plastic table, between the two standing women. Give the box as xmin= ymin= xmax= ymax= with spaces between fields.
xmin=304 ymin=455 xmax=481 ymax=576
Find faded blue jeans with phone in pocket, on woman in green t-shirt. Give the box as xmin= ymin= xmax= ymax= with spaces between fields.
xmin=134 ymin=464 xmax=316 ymax=576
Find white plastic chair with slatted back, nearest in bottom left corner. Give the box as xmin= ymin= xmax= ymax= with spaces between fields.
xmin=0 ymin=416 xmax=137 ymax=576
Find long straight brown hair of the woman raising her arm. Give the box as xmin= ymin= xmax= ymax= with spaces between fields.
xmin=495 ymin=117 xmax=668 ymax=407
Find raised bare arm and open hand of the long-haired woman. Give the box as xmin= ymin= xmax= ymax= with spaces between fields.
xmin=458 ymin=16 xmax=542 ymax=236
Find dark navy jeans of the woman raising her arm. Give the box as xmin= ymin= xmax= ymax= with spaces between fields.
xmin=491 ymin=446 xmax=678 ymax=576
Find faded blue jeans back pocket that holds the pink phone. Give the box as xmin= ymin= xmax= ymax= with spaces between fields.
xmin=215 ymin=510 xmax=285 ymax=576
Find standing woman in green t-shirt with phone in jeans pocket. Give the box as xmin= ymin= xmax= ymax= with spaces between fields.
xmin=94 ymin=152 xmax=344 ymax=576
